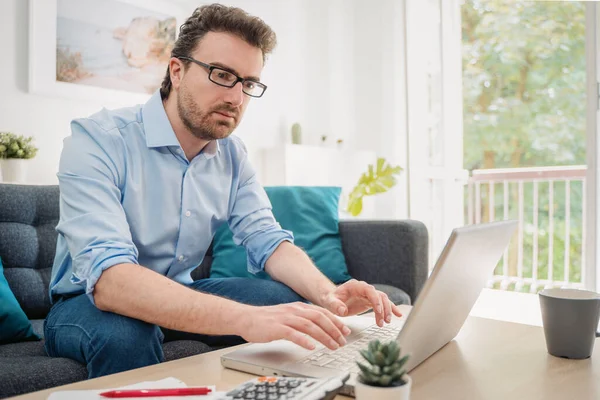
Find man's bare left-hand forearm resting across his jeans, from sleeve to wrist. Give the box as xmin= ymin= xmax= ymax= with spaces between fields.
xmin=93 ymin=264 xmax=250 ymax=335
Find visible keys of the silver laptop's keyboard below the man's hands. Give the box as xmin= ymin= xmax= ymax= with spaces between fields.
xmin=300 ymin=321 xmax=404 ymax=373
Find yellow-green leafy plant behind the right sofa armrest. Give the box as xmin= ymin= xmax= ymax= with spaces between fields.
xmin=347 ymin=158 xmax=402 ymax=217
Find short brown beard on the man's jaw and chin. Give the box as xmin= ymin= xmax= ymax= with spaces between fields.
xmin=177 ymin=87 xmax=239 ymax=140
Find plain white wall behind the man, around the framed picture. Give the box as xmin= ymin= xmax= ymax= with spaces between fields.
xmin=0 ymin=0 xmax=406 ymax=217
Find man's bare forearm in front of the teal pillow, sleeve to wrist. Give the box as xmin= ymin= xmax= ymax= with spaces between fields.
xmin=265 ymin=241 xmax=335 ymax=305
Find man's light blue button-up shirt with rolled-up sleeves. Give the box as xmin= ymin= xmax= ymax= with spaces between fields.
xmin=50 ymin=92 xmax=293 ymax=302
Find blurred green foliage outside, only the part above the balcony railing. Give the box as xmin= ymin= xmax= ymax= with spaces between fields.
xmin=462 ymin=0 xmax=586 ymax=170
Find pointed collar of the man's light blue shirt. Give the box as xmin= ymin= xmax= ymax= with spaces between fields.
xmin=142 ymin=90 xmax=221 ymax=157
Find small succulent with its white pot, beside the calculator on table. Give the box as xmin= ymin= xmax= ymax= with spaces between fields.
xmin=355 ymin=339 xmax=412 ymax=400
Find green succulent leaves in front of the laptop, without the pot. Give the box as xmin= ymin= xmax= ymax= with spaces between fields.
xmin=356 ymin=339 xmax=409 ymax=387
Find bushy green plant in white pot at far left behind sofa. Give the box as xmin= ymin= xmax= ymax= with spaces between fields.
xmin=0 ymin=132 xmax=38 ymax=183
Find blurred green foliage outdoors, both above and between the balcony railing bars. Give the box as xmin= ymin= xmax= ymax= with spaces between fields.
xmin=461 ymin=0 xmax=586 ymax=290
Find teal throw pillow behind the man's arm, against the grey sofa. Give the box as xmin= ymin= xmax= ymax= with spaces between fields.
xmin=210 ymin=186 xmax=350 ymax=284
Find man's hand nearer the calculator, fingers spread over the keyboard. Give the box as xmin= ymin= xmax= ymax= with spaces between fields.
xmin=236 ymin=302 xmax=350 ymax=350
